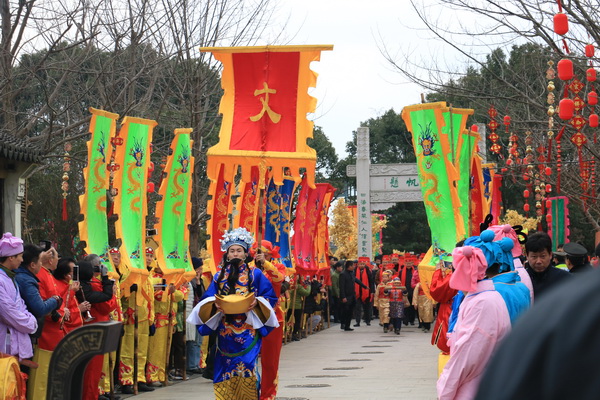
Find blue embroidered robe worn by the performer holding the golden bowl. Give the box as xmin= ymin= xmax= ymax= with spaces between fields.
xmin=198 ymin=264 xmax=277 ymax=400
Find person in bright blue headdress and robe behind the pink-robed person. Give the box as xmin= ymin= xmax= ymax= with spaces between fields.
xmin=465 ymin=229 xmax=531 ymax=324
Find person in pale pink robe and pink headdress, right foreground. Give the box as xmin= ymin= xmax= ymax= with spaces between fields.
xmin=437 ymin=246 xmax=511 ymax=400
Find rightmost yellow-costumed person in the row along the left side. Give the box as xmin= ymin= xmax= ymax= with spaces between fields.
xmin=146 ymin=266 xmax=184 ymax=383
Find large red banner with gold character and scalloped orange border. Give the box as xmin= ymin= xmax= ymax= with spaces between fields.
xmin=200 ymin=45 xmax=333 ymax=188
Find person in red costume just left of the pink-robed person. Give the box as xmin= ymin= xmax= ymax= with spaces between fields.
xmin=429 ymin=267 xmax=458 ymax=354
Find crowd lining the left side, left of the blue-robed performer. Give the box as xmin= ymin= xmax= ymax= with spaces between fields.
xmin=0 ymin=233 xmax=209 ymax=400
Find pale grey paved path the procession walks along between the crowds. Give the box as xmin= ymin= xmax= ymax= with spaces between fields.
xmin=136 ymin=320 xmax=438 ymax=400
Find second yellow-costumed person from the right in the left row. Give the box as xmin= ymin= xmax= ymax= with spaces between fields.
xmin=119 ymin=248 xmax=154 ymax=394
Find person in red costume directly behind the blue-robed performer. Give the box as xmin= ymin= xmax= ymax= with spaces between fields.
xmin=250 ymin=240 xmax=285 ymax=400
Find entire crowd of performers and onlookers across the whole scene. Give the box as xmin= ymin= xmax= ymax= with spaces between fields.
xmin=0 ymin=225 xmax=600 ymax=400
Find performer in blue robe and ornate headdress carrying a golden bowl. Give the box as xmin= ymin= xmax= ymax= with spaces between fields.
xmin=188 ymin=228 xmax=279 ymax=400
